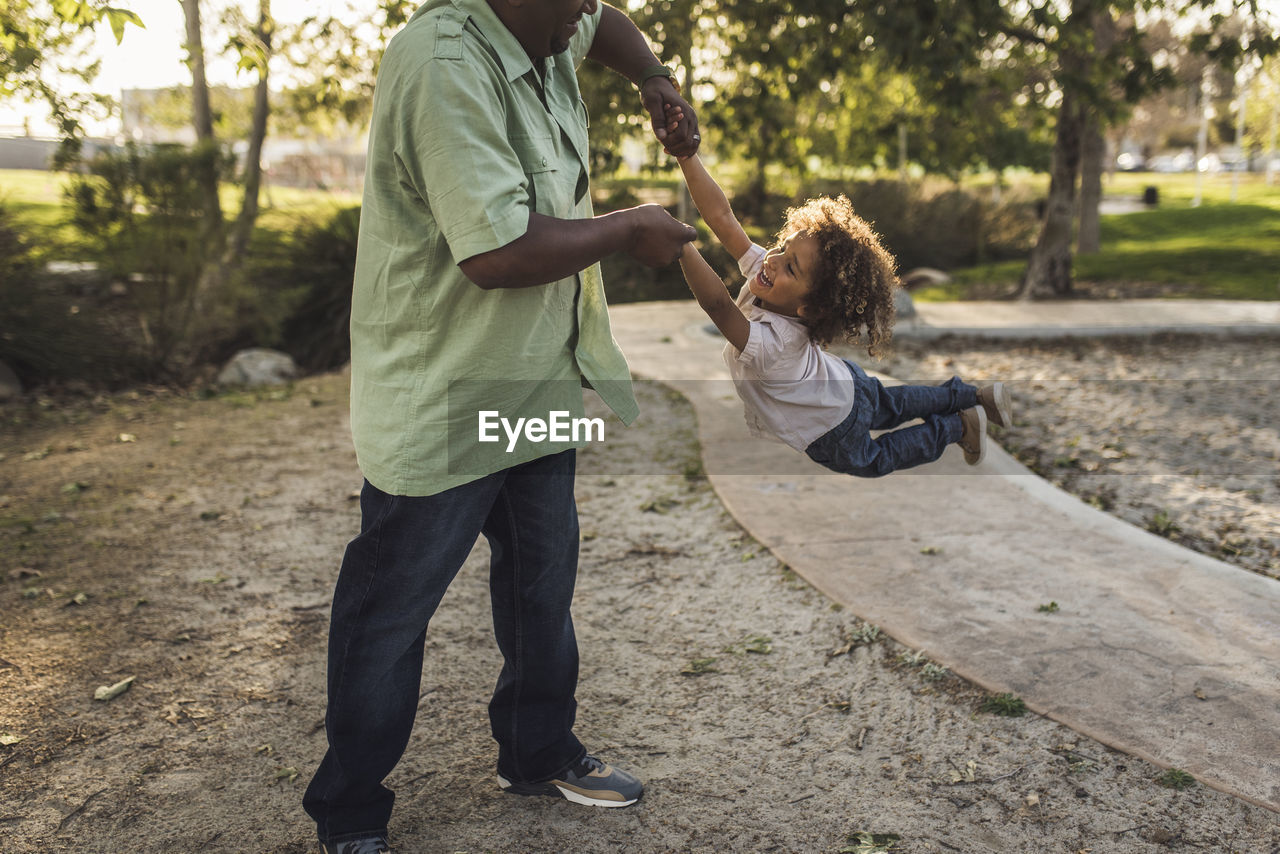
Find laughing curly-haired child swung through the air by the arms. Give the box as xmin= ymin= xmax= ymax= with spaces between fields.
xmin=680 ymin=111 xmax=1011 ymax=478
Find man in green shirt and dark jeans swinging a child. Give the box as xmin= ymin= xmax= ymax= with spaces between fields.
xmin=303 ymin=0 xmax=699 ymax=854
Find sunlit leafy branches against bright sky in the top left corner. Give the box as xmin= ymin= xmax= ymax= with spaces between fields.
xmin=0 ymin=0 xmax=142 ymax=160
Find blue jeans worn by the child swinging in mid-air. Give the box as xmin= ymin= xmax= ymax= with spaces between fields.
xmin=805 ymin=359 xmax=978 ymax=478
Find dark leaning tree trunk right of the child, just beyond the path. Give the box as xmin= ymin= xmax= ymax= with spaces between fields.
xmin=1018 ymin=92 xmax=1083 ymax=300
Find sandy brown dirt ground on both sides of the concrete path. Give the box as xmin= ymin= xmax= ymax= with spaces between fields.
xmin=0 ymin=341 xmax=1280 ymax=854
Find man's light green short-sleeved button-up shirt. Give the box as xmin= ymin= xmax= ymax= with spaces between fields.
xmin=351 ymin=0 xmax=637 ymax=495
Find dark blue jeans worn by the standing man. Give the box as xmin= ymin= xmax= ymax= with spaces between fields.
xmin=303 ymin=451 xmax=586 ymax=842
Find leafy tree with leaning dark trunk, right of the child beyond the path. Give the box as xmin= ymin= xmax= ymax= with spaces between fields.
xmin=851 ymin=0 xmax=1276 ymax=297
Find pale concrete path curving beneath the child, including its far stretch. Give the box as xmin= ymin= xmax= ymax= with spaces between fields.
xmin=611 ymin=301 xmax=1280 ymax=812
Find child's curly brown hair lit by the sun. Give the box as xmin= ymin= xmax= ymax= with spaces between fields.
xmin=778 ymin=196 xmax=897 ymax=357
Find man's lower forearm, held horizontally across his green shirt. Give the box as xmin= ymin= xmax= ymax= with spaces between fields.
xmin=458 ymin=210 xmax=634 ymax=291
